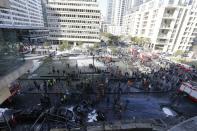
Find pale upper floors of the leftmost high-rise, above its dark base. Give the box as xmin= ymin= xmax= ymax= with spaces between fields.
xmin=0 ymin=0 xmax=44 ymax=29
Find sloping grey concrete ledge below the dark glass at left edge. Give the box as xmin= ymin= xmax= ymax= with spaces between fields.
xmin=0 ymin=61 xmax=32 ymax=104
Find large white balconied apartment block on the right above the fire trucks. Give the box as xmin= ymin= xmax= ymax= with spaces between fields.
xmin=122 ymin=0 xmax=197 ymax=53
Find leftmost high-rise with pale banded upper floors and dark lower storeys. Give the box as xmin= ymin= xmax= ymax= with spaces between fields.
xmin=0 ymin=0 xmax=47 ymax=44
